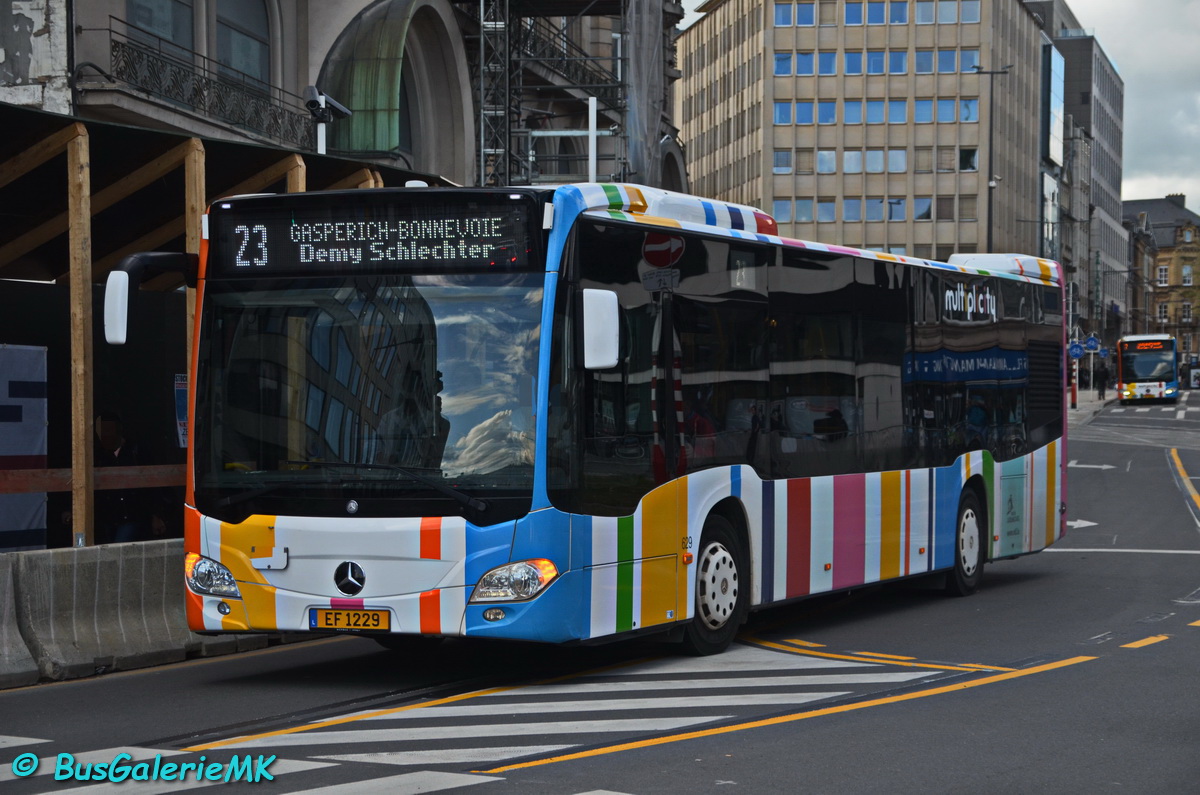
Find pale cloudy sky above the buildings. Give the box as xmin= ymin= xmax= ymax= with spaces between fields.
xmin=684 ymin=0 xmax=1200 ymax=213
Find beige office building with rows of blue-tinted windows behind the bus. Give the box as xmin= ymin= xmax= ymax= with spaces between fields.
xmin=677 ymin=0 xmax=1046 ymax=259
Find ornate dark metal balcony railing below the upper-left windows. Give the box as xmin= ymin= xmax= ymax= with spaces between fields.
xmin=79 ymin=17 xmax=316 ymax=149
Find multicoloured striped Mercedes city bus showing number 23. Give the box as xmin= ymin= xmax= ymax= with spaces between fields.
xmin=106 ymin=184 xmax=1066 ymax=654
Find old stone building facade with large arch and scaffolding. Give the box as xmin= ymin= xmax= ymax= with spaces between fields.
xmin=0 ymin=0 xmax=684 ymax=189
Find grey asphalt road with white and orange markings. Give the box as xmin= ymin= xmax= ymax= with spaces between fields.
xmin=0 ymin=393 xmax=1200 ymax=795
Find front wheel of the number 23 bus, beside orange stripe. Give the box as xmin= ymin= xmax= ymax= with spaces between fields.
xmin=683 ymin=514 xmax=750 ymax=656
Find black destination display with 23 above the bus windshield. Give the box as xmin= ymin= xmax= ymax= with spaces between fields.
xmin=209 ymin=194 xmax=530 ymax=276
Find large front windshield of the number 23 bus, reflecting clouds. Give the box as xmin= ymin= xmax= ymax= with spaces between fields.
xmin=194 ymin=273 xmax=542 ymax=521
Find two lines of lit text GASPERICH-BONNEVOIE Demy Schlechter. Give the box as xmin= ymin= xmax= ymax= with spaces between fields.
xmin=290 ymin=216 xmax=505 ymax=264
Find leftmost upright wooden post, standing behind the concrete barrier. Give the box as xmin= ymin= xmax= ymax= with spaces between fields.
xmin=67 ymin=130 xmax=96 ymax=546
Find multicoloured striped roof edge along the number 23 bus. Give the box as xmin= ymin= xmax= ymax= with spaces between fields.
xmin=556 ymin=183 xmax=1062 ymax=285
